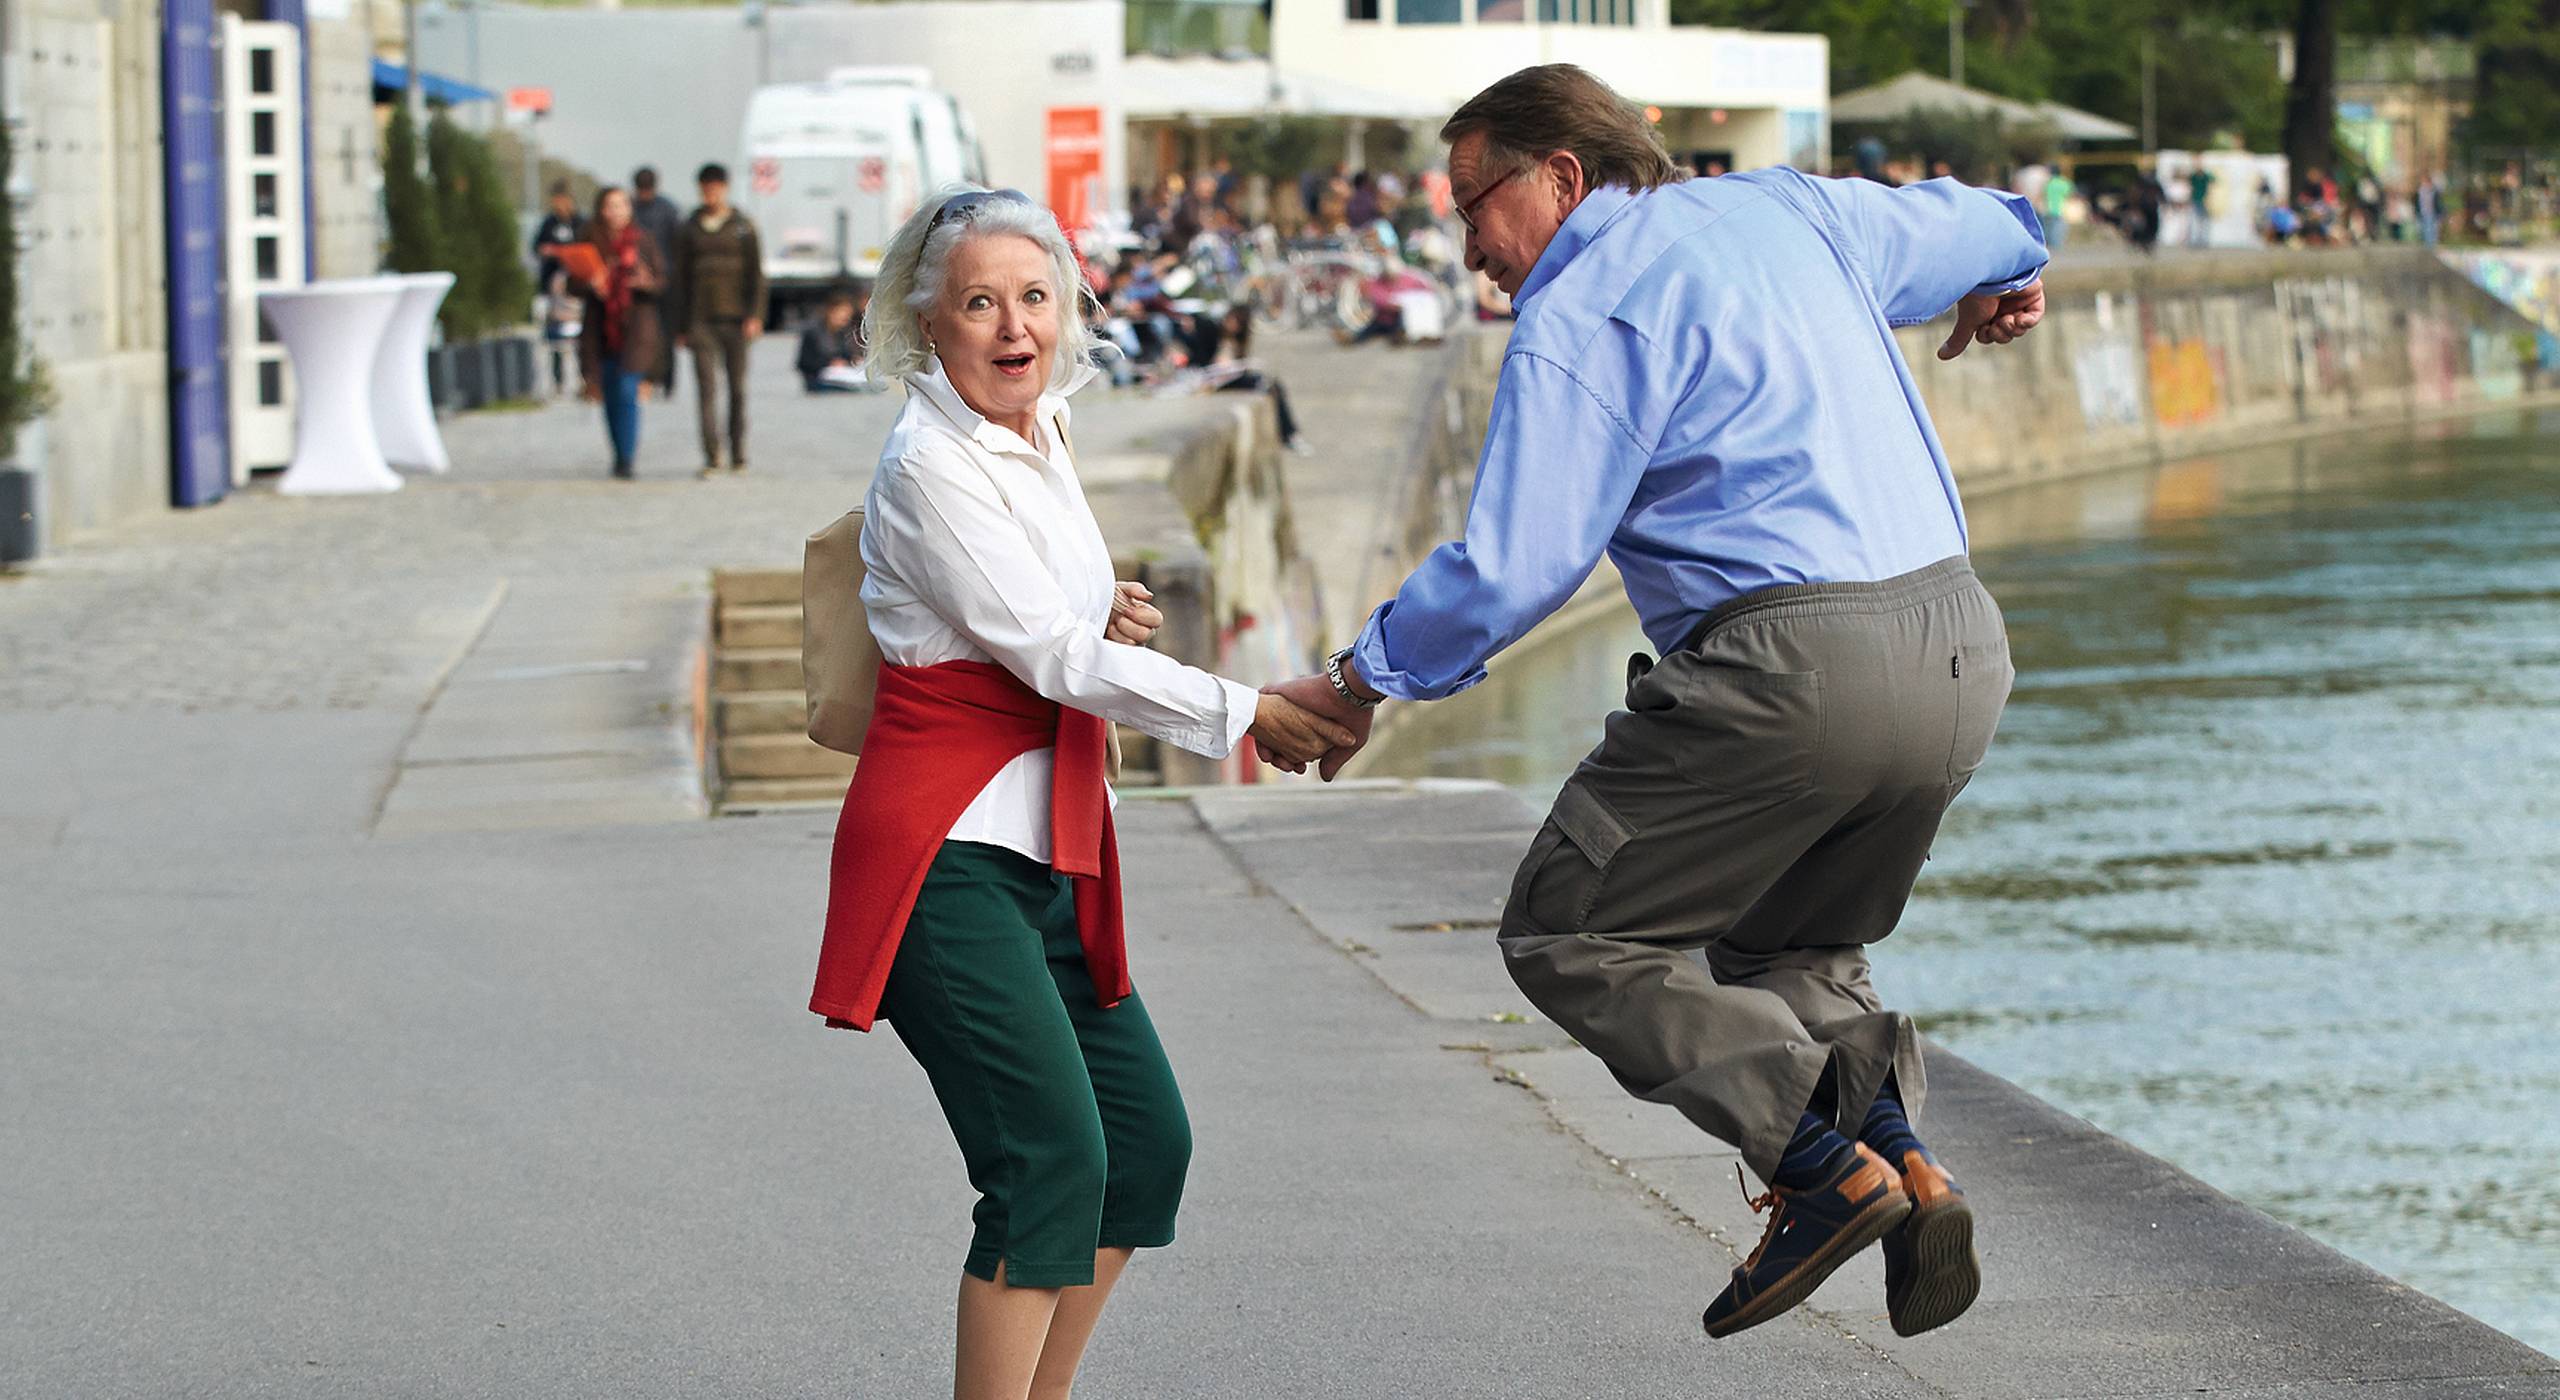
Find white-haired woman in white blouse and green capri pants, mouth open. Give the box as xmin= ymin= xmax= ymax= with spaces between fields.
xmin=809 ymin=187 xmax=1352 ymax=1400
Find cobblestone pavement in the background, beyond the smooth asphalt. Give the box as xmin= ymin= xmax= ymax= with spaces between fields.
xmin=0 ymin=335 xmax=1434 ymax=712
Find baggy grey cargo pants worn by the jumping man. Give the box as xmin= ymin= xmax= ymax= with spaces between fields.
xmin=1500 ymin=558 xmax=2012 ymax=1180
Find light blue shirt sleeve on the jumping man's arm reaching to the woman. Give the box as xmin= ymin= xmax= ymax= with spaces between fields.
xmin=1352 ymin=351 xmax=1651 ymax=701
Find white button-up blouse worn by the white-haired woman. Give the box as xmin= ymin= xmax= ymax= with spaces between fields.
xmin=863 ymin=361 xmax=1260 ymax=863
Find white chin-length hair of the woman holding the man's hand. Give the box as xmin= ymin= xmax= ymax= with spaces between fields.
xmin=863 ymin=184 xmax=1098 ymax=392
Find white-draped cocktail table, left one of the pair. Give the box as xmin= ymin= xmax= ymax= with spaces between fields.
xmin=259 ymin=276 xmax=407 ymax=497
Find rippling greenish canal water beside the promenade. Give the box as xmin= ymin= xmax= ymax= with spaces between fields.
xmin=1364 ymin=415 xmax=2560 ymax=1354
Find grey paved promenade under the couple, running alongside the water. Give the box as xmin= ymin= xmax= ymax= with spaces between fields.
xmin=0 ymin=335 xmax=2560 ymax=1400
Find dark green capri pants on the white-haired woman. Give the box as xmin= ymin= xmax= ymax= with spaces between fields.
xmin=881 ymin=842 xmax=1190 ymax=1287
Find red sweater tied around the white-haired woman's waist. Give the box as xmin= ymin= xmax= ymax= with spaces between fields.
xmin=809 ymin=660 xmax=1129 ymax=1031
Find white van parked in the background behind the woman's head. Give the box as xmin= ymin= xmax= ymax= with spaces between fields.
xmin=737 ymin=67 xmax=986 ymax=315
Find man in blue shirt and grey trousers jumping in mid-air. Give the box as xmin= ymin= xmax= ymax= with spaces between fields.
xmin=1283 ymin=64 xmax=2045 ymax=1336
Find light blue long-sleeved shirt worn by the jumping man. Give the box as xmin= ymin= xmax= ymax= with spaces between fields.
xmin=1354 ymin=169 xmax=2045 ymax=699
